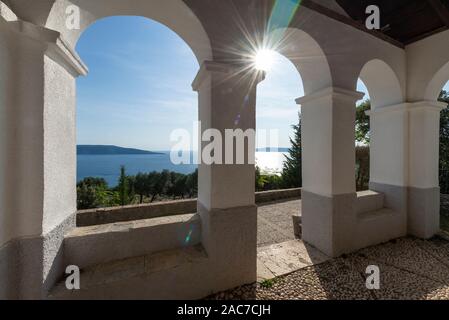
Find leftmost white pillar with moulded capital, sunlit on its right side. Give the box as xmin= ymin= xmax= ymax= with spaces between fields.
xmin=0 ymin=21 xmax=87 ymax=298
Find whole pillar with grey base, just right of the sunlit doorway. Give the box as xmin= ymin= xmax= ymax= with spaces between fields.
xmin=297 ymin=87 xmax=363 ymax=257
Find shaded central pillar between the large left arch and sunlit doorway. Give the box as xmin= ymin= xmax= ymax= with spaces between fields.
xmin=193 ymin=61 xmax=263 ymax=292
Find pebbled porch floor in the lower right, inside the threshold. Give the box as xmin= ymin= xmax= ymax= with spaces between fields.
xmin=209 ymin=237 xmax=449 ymax=300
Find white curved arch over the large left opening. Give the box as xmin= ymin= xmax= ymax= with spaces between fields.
xmin=46 ymin=0 xmax=212 ymax=65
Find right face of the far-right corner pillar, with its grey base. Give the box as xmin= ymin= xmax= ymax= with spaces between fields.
xmin=408 ymin=101 xmax=446 ymax=239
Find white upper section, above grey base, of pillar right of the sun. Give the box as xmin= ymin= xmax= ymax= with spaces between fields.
xmin=297 ymin=88 xmax=363 ymax=197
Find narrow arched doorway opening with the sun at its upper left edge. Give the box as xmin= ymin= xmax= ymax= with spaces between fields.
xmin=256 ymin=51 xmax=304 ymax=247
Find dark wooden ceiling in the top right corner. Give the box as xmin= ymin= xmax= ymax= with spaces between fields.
xmin=336 ymin=0 xmax=449 ymax=45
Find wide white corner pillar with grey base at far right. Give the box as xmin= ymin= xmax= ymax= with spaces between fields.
xmin=367 ymin=101 xmax=445 ymax=238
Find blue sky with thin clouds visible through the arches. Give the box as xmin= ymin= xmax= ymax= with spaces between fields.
xmin=77 ymin=17 xmax=449 ymax=150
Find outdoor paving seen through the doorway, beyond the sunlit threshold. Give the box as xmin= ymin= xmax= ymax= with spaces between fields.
xmin=257 ymin=200 xmax=301 ymax=247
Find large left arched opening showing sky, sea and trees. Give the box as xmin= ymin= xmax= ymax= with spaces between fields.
xmin=77 ymin=16 xmax=199 ymax=209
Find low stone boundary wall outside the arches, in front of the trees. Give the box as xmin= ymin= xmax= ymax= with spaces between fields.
xmin=76 ymin=189 xmax=301 ymax=227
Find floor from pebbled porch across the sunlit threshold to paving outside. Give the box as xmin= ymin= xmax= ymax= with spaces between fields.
xmin=220 ymin=200 xmax=449 ymax=300
